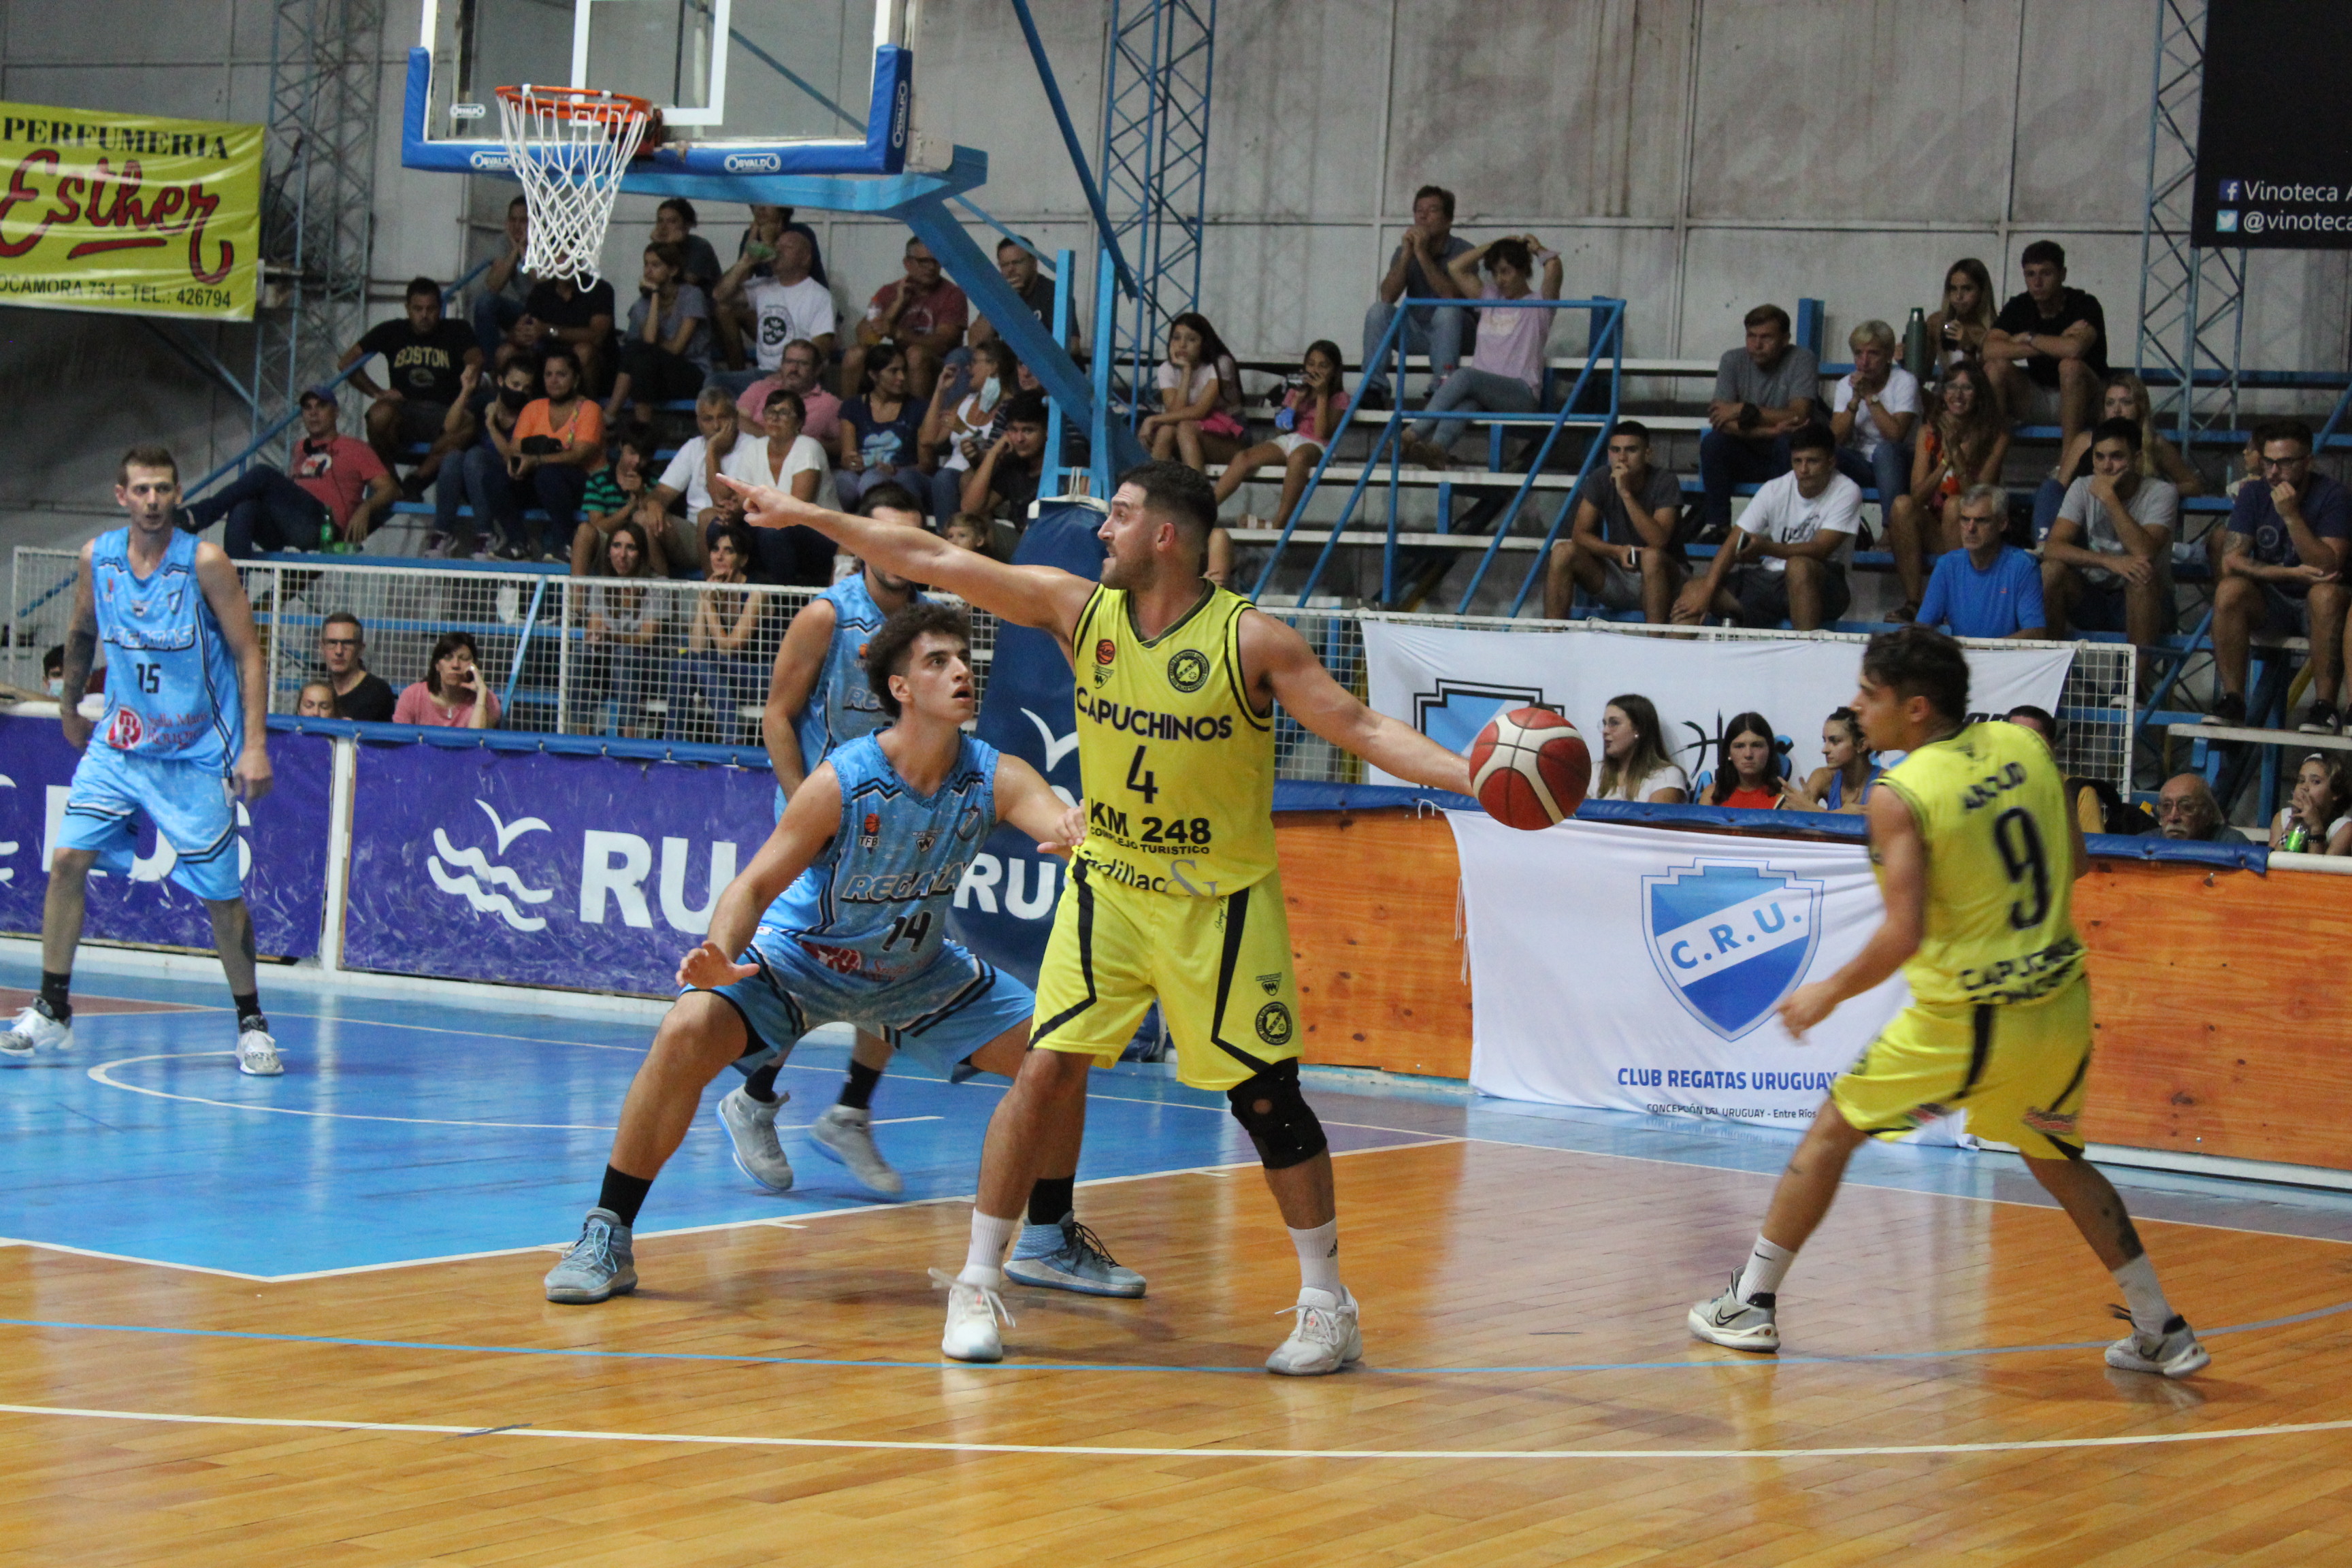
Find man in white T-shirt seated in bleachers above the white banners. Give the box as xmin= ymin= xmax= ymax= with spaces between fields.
xmin=1675 ymin=425 xmax=1863 ymax=632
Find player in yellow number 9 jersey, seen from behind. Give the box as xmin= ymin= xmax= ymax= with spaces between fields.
xmin=1688 ymin=625 xmax=2211 ymax=1377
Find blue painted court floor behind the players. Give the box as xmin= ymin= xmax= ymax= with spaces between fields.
xmin=0 ymin=952 xmax=2352 ymax=1279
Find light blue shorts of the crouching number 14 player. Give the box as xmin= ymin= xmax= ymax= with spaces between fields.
xmin=696 ymin=931 xmax=1037 ymax=1077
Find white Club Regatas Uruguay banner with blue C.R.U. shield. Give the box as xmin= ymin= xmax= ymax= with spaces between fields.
xmin=1446 ymin=811 xmax=1910 ymax=1128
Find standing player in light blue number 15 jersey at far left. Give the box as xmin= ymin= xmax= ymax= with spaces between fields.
xmin=0 ymin=446 xmax=284 ymax=1077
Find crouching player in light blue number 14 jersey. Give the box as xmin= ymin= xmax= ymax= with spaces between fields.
xmin=546 ymin=604 xmax=1143 ymax=1305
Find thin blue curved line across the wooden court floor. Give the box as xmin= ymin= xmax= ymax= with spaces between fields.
xmin=0 ymin=1303 xmax=2352 ymax=1377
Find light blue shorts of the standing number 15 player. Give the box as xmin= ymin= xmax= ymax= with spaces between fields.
xmin=56 ymin=736 xmax=244 ymax=902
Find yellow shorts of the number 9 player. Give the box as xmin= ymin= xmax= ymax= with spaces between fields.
xmin=1830 ymin=976 xmax=2091 ymax=1159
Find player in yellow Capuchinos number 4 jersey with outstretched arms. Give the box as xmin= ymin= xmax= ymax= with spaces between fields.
xmin=715 ymin=463 xmax=1470 ymax=1375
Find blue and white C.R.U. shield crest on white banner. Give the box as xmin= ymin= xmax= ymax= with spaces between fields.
xmin=1642 ymin=858 xmax=1820 ymax=1039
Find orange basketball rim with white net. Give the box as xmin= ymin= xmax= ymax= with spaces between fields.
xmin=499 ymin=84 xmax=654 ymax=289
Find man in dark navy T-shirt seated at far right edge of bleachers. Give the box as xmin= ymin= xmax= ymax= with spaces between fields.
xmin=2206 ymin=419 xmax=2352 ymax=736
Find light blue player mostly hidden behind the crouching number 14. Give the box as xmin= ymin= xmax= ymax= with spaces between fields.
xmin=743 ymin=485 xmax=922 ymax=1196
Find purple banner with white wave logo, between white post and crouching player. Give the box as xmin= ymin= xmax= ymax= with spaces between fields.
xmin=344 ymin=743 xmax=776 ymax=994
